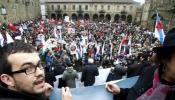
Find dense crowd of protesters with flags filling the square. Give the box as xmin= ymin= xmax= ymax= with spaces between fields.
xmin=0 ymin=19 xmax=159 ymax=87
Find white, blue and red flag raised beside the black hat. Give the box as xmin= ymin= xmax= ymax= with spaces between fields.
xmin=154 ymin=13 xmax=165 ymax=44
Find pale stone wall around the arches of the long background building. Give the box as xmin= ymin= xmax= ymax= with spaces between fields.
xmin=45 ymin=2 xmax=141 ymax=21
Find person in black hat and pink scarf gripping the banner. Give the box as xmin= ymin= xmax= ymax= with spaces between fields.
xmin=106 ymin=28 xmax=175 ymax=100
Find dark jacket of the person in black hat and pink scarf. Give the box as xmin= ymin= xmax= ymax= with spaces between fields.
xmin=114 ymin=66 xmax=175 ymax=100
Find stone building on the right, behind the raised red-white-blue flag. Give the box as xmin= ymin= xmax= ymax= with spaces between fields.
xmin=141 ymin=0 xmax=175 ymax=30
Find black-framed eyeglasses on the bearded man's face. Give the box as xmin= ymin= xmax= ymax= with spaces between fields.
xmin=11 ymin=61 xmax=44 ymax=75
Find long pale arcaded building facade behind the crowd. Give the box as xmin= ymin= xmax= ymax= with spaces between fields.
xmin=45 ymin=0 xmax=141 ymax=22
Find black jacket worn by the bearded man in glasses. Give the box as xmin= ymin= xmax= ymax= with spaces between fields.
xmin=0 ymin=86 xmax=49 ymax=100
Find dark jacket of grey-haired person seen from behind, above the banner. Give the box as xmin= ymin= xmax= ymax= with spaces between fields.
xmin=81 ymin=64 xmax=99 ymax=86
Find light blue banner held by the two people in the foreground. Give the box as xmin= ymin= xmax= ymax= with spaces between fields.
xmin=50 ymin=76 xmax=138 ymax=100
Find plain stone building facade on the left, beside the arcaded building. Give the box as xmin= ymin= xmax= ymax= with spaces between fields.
xmin=0 ymin=0 xmax=40 ymax=22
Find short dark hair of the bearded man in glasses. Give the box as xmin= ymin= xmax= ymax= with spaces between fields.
xmin=0 ymin=40 xmax=37 ymax=86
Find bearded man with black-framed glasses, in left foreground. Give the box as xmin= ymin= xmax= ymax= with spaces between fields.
xmin=0 ymin=41 xmax=71 ymax=100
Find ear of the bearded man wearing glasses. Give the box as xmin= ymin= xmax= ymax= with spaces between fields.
xmin=0 ymin=74 xmax=15 ymax=87
